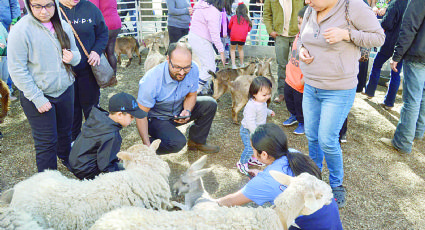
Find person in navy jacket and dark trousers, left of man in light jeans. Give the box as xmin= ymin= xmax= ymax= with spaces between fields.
xmin=365 ymin=0 xmax=408 ymax=109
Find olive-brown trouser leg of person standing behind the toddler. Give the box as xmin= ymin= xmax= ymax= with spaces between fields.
xmin=275 ymin=36 xmax=295 ymax=95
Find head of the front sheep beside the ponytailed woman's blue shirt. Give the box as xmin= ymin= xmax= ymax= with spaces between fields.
xmin=270 ymin=170 xmax=333 ymax=227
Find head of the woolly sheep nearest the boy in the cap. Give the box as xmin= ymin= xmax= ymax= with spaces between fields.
xmin=117 ymin=139 xmax=168 ymax=172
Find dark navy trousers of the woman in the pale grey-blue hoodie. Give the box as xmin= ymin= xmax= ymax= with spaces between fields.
xmin=19 ymin=85 xmax=74 ymax=172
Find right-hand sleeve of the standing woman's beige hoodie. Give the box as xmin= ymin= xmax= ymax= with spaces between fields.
xmin=349 ymin=2 xmax=385 ymax=48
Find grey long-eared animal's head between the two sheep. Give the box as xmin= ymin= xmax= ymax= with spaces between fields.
xmin=173 ymin=155 xmax=212 ymax=196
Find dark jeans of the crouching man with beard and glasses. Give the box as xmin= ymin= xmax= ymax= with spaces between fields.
xmin=149 ymin=96 xmax=217 ymax=154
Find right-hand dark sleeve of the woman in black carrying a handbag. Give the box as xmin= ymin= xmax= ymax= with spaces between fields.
xmin=89 ymin=4 xmax=109 ymax=56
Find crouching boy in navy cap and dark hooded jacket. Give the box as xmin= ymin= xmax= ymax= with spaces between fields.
xmin=69 ymin=93 xmax=147 ymax=179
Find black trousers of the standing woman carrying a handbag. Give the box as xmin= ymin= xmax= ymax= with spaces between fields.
xmin=72 ymin=66 xmax=100 ymax=141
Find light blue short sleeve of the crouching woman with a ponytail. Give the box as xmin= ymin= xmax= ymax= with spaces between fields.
xmin=241 ymin=172 xmax=275 ymax=205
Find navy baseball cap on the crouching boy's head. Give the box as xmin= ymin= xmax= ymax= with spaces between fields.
xmin=109 ymin=93 xmax=148 ymax=119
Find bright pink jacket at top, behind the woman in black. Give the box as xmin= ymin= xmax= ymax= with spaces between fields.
xmin=89 ymin=0 xmax=121 ymax=30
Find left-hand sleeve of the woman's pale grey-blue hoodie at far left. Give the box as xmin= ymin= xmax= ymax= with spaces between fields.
xmin=7 ymin=28 xmax=49 ymax=108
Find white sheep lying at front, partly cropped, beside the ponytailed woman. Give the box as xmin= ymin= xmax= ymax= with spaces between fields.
xmin=91 ymin=171 xmax=332 ymax=230
